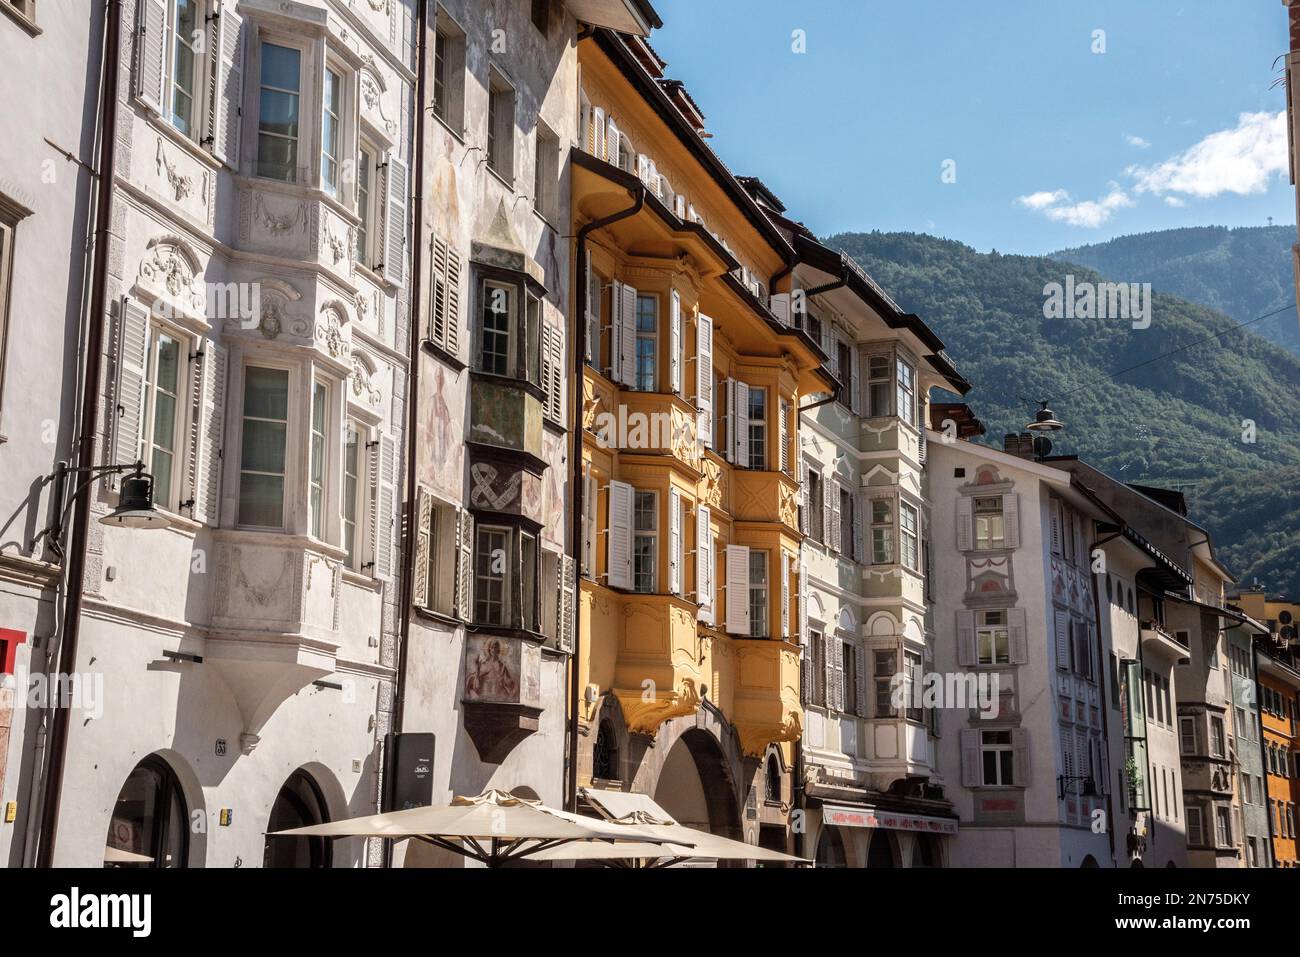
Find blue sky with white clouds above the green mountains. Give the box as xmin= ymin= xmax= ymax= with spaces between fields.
xmin=650 ymin=0 xmax=1295 ymax=254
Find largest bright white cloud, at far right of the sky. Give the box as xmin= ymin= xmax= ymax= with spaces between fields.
xmin=1125 ymin=111 xmax=1287 ymax=199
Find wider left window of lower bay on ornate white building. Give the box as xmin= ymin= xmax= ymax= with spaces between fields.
xmin=239 ymin=365 xmax=289 ymax=528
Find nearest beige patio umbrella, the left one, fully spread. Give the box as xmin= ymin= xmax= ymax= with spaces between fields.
xmin=268 ymin=791 xmax=681 ymax=867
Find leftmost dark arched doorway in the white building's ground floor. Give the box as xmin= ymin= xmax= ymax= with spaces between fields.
xmin=104 ymin=754 xmax=190 ymax=867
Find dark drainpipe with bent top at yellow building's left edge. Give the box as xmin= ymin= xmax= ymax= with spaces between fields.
xmin=566 ymin=182 xmax=646 ymax=814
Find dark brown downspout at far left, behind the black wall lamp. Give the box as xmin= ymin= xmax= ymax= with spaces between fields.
xmin=36 ymin=0 xmax=122 ymax=867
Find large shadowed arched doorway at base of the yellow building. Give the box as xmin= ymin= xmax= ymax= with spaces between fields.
xmin=653 ymin=728 xmax=745 ymax=841
